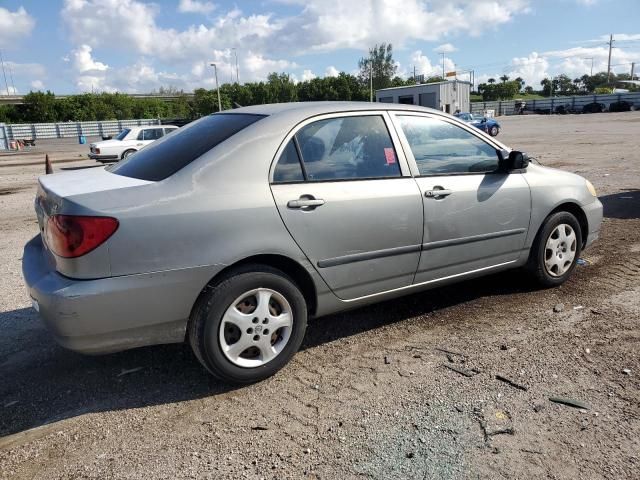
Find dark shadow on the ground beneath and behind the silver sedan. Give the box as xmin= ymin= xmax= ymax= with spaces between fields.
xmin=0 ymin=271 xmax=535 ymax=445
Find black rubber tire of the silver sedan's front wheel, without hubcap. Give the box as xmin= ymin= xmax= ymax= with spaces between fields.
xmin=526 ymin=212 xmax=582 ymax=287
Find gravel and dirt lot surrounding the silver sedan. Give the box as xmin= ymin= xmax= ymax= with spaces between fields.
xmin=0 ymin=112 xmax=640 ymax=479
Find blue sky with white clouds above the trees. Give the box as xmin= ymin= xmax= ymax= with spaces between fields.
xmin=0 ymin=0 xmax=640 ymax=94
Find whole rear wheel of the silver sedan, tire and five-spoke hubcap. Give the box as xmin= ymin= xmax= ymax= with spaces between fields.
xmin=189 ymin=265 xmax=307 ymax=384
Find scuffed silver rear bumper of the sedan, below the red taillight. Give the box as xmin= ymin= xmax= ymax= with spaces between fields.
xmin=22 ymin=235 xmax=211 ymax=354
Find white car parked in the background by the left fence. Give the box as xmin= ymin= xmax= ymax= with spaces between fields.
xmin=89 ymin=125 xmax=178 ymax=163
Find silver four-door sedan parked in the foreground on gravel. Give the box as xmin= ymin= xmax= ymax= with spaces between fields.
xmin=23 ymin=102 xmax=602 ymax=383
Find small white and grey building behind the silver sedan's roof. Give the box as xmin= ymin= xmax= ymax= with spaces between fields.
xmin=376 ymin=80 xmax=471 ymax=113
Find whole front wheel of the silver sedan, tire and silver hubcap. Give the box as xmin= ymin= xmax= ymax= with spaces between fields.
xmin=527 ymin=212 xmax=582 ymax=287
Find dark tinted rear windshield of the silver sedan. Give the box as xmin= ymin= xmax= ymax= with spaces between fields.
xmin=111 ymin=113 xmax=264 ymax=181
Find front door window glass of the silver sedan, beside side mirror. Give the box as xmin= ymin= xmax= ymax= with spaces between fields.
xmin=398 ymin=116 xmax=498 ymax=175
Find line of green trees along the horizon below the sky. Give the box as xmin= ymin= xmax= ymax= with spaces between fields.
xmin=0 ymin=43 xmax=633 ymax=123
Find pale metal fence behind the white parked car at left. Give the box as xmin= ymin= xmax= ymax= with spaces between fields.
xmin=0 ymin=119 xmax=160 ymax=144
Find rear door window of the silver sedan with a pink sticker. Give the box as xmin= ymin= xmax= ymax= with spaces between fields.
xmin=296 ymin=116 xmax=400 ymax=181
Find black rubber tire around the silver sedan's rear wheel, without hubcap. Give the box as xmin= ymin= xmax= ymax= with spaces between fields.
xmin=188 ymin=264 xmax=307 ymax=384
